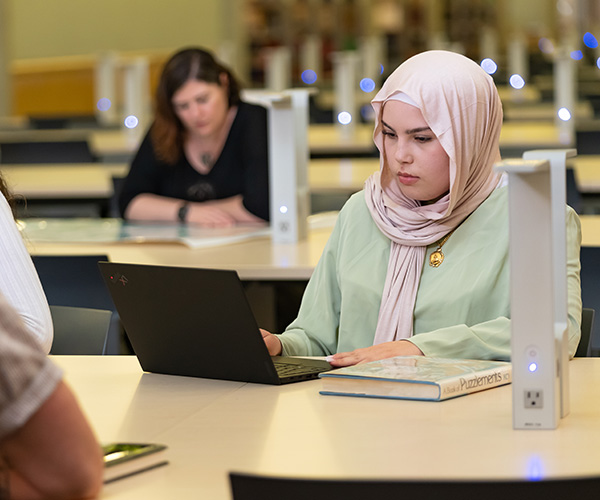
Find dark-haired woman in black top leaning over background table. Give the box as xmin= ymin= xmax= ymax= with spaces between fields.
xmin=119 ymin=48 xmax=269 ymax=227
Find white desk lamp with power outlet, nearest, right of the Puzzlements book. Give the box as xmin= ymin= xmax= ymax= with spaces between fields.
xmin=494 ymin=146 xmax=575 ymax=429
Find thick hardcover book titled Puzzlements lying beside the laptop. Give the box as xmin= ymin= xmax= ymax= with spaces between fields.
xmin=319 ymin=356 xmax=512 ymax=401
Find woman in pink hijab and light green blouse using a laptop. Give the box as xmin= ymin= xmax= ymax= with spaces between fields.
xmin=263 ymin=51 xmax=581 ymax=366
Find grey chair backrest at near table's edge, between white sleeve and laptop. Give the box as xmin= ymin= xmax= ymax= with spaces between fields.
xmin=50 ymin=306 xmax=112 ymax=354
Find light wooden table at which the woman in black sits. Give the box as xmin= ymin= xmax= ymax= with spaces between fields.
xmin=24 ymin=218 xmax=335 ymax=281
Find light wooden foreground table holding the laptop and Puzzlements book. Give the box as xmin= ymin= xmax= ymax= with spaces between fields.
xmin=53 ymin=356 xmax=600 ymax=500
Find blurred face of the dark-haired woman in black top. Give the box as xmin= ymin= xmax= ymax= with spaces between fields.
xmin=171 ymin=80 xmax=229 ymax=137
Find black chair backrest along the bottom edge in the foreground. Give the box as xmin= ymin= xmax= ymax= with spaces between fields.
xmin=229 ymin=473 xmax=600 ymax=500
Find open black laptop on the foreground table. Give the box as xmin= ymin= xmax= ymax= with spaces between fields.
xmin=98 ymin=262 xmax=331 ymax=384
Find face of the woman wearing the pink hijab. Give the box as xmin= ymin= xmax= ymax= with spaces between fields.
xmin=381 ymin=100 xmax=450 ymax=202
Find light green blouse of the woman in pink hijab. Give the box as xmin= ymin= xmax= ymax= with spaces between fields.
xmin=279 ymin=186 xmax=581 ymax=360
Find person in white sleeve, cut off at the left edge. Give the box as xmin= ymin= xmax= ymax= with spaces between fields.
xmin=0 ymin=176 xmax=54 ymax=354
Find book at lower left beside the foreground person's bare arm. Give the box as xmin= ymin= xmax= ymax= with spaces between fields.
xmin=102 ymin=443 xmax=169 ymax=484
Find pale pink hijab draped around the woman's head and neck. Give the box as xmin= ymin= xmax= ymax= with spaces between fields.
xmin=365 ymin=50 xmax=502 ymax=344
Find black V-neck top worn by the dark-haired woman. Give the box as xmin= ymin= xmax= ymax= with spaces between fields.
xmin=119 ymin=102 xmax=269 ymax=220
